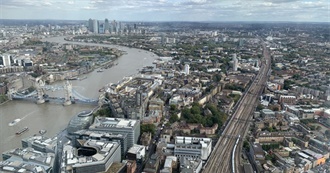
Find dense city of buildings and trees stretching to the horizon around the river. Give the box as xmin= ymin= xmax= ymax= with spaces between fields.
xmin=0 ymin=19 xmax=330 ymax=173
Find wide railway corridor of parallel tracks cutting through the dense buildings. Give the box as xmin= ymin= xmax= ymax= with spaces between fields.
xmin=203 ymin=44 xmax=271 ymax=173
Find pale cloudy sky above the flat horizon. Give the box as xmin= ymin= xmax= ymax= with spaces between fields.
xmin=0 ymin=0 xmax=330 ymax=22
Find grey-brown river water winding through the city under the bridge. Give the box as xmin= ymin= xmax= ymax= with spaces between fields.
xmin=0 ymin=37 xmax=157 ymax=157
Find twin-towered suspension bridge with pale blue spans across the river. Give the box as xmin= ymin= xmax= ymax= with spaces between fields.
xmin=8 ymin=78 xmax=103 ymax=106
